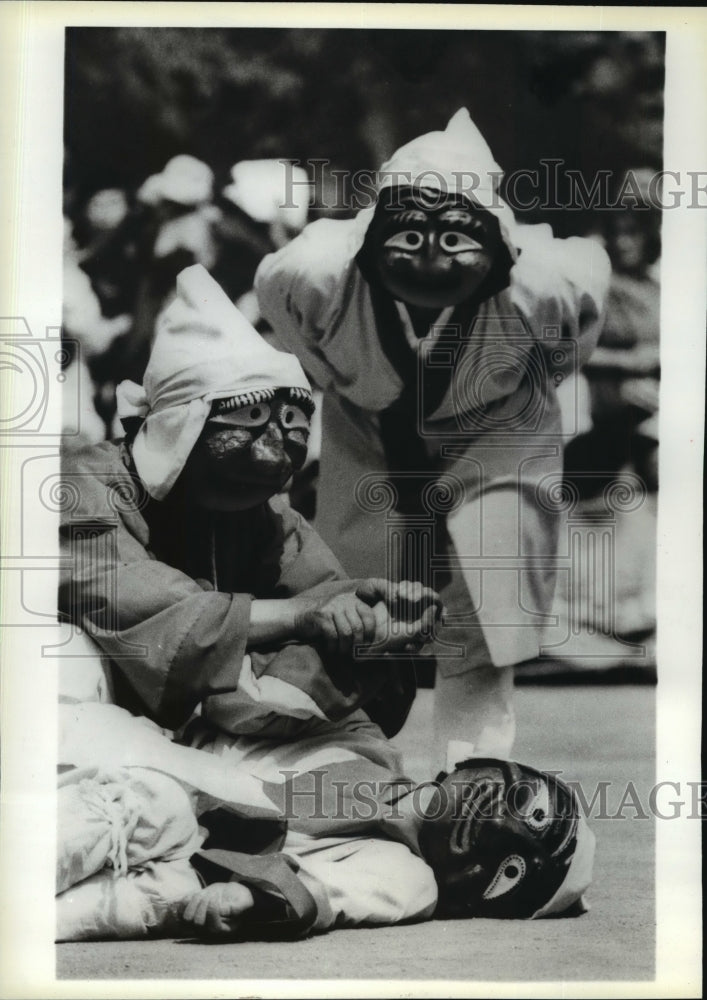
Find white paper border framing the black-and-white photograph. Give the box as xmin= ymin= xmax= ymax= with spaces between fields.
xmin=0 ymin=2 xmax=707 ymax=1000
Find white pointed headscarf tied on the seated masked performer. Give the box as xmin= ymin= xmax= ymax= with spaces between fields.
xmin=117 ymin=264 xmax=311 ymax=500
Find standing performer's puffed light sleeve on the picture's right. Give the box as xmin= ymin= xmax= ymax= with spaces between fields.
xmin=510 ymin=225 xmax=611 ymax=367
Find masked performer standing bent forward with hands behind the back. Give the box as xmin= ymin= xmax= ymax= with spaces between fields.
xmin=255 ymin=109 xmax=609 ymax=767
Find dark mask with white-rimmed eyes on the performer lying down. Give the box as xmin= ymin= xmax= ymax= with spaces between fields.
xmin=420 ymin=758 xmax=594 ymax=919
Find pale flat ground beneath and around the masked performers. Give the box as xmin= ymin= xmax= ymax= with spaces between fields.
xmin=57 ymin=685 xmax=655 ymax=997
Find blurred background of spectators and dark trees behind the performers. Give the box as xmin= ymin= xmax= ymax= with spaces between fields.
xmin=63 ymin=28 xmax=664 ymax=677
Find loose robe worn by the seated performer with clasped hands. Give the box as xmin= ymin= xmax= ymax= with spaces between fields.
xmin=59 ymin=442 xmax=415 ymax=739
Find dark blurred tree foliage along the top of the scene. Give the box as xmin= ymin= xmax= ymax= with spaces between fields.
xmin=65 ymin=28 xmax=664 ymax=228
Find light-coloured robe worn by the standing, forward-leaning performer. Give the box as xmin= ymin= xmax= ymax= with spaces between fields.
xmin=255 ymin=219 xmax=610 ymax=674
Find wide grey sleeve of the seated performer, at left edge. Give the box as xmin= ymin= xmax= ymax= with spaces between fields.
xmin=59 ymin=448 xmax=251 ymax=729
